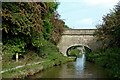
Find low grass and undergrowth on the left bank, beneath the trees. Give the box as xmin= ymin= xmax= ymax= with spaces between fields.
xmin=2 ymin=37 xmax=75 ymax=78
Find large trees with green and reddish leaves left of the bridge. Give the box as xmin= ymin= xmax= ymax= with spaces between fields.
xmin=2 ymin=2 xmax=65 ymax=56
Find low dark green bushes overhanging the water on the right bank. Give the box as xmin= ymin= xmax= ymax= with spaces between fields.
xmin=86 ymin=48 xmax=120 ymax=78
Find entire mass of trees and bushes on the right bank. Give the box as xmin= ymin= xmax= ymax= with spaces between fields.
xmin=86 ymin=2 xmax=120 ymax=78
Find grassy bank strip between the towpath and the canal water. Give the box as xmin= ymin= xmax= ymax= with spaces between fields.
xmin=2 ymin=56 xmax=75 ymax=78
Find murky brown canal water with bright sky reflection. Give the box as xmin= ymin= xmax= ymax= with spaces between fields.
xmin=29 ymin=54 xmax=109 ymax=78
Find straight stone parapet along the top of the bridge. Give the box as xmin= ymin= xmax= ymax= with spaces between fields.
xmin=62 ymin=29 xmax=96 ymax=35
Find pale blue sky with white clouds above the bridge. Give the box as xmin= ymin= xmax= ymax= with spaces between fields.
xmin=57 ymin=0 xmax=119 ymax=29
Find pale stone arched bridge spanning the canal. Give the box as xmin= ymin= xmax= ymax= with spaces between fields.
xmin=57 ymin=29 xmax=101 ymax=56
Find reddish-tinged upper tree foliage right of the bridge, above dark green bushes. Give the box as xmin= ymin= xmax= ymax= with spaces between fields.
xmin=95 ymin=2 xmax=120 ymax=49
